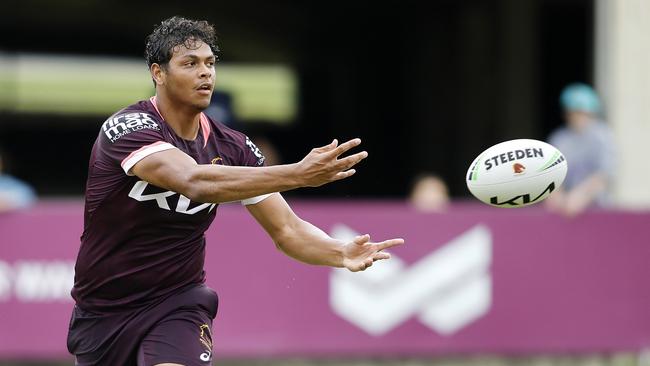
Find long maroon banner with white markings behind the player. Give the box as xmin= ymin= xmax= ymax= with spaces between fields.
xmin=0 ymin=201 xmax=650 ymax=358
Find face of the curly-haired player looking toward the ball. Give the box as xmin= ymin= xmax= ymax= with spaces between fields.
xmin=152 ymin=41 xmax=216 ymax=111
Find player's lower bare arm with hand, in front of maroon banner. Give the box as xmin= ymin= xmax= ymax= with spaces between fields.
xmin=246 ymin=193 xmax=404 ymax=272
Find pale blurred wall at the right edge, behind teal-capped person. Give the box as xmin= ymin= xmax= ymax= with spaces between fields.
xmin=595 ymin=0 xmax=650 ymax=207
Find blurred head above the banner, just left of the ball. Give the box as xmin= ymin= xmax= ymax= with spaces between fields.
xmin=409 ymin=173 xmax=449 ymax=212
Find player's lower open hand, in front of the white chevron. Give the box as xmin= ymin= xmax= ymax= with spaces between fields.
xmin=343 ymin=234 xmax=404 ymax=272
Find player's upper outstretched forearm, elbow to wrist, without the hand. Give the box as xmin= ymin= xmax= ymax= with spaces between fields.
xmin=186 ymin=164 xmax=304 ymax=203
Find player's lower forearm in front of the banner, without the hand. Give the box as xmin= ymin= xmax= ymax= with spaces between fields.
xmin=273 ymin=219 xmax=343 ymax=267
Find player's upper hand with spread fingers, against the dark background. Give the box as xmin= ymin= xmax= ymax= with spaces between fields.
xmin=297 ymin=138 xmax=368 ymax=187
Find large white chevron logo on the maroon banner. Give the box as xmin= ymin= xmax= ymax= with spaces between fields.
xmin=330 ymin=224 xmax=492 ymax=336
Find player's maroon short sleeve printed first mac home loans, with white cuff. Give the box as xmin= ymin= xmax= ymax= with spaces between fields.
xmin=98 ymin=112 xmax=176 ymax=175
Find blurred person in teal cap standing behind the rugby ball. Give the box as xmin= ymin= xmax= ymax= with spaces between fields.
xmin=546 ymin=83 xmax=615 ymax=217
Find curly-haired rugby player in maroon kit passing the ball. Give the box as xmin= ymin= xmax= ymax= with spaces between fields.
xmin=68 ymin=17 xmax=403 ymax=365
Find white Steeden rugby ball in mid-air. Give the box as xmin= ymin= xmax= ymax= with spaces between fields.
xmin=466 ymin=139 xmax=567 ymax=208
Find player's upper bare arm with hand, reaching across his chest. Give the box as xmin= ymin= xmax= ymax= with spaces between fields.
xmin=131 ymin=139 xmax=368 ymax=203
